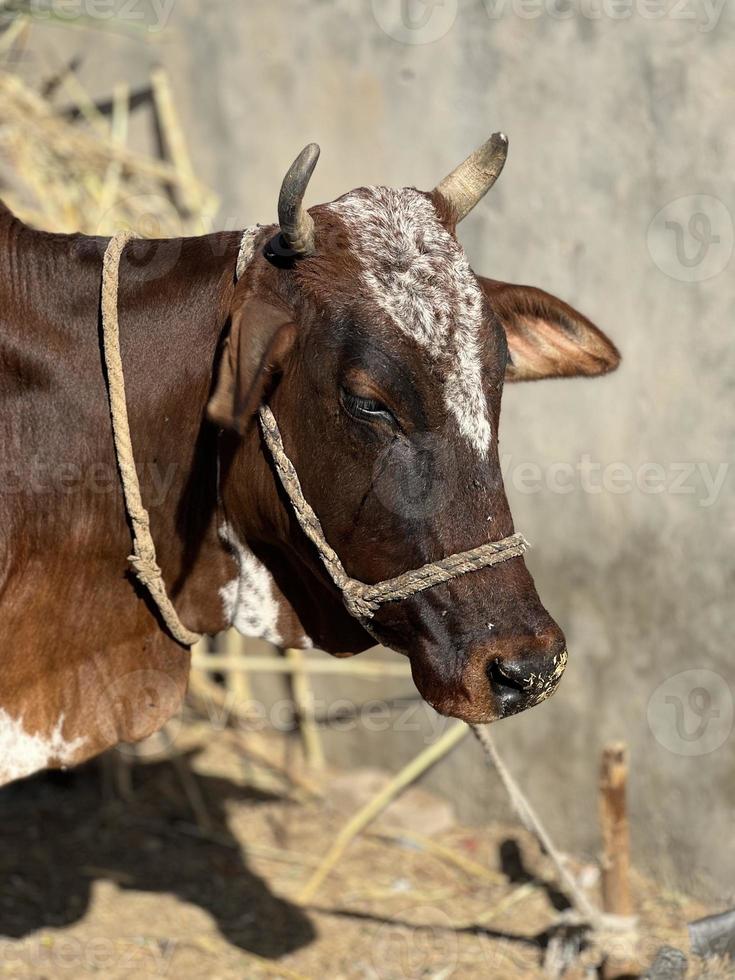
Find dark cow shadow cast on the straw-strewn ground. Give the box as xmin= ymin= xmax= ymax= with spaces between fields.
xmin=0 ymin=759 xmax=315 ymax=959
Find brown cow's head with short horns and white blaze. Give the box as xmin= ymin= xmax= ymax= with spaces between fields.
xmin=210 ymin=135 xmax=619 ymax=722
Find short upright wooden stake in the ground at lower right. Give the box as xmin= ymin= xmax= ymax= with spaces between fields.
xmin=599 ymin=742 xmax=633 ymax=915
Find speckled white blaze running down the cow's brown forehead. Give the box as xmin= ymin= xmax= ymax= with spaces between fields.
xmin=327 ymin=187 xmax=492 ymax=459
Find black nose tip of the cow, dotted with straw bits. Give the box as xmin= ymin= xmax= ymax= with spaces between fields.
xmin=485 ymin=642 xmax=567 ymax=716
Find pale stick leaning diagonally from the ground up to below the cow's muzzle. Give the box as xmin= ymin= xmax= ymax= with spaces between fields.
xmin=297 ymin=722 xmax=470 ymax=905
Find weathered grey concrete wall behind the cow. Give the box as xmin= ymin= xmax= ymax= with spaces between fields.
xmin=25 ymin=0 xmax=735 ymax=903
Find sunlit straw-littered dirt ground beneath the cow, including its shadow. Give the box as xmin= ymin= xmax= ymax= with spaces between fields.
xmin=0 ymin=723 xmax=733 ymax=980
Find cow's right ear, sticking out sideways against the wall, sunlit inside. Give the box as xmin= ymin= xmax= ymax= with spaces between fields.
xmin=479 ymin=277 xmax=620 ymax=381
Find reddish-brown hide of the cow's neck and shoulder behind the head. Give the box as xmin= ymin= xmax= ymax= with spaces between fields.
xmin=0 ymin=211 xmax=238 ymax=775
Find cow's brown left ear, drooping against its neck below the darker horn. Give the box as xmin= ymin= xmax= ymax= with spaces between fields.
xmin=207 ymin=293 xmax=296 ymax=434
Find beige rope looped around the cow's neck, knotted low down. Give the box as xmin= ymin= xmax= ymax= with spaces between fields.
xmin=101 ymin=231 xmax=201 ymax=646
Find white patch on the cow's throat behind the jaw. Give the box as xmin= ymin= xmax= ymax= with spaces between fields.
xmin=219 ymin=523 xmax=281 ymax=646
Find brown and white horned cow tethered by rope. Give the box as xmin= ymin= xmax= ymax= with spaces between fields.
xmin=0 ymin=137 xmax=619 ymax=782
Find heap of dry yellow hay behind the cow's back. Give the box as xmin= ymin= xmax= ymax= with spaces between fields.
xmin=0 ymin=64 xmax=217 ymax=237
